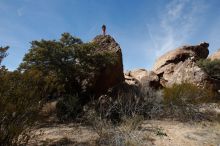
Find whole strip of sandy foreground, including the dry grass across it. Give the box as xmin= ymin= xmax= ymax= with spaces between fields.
xmin=25 ymin=104 xmax=220 ymax=146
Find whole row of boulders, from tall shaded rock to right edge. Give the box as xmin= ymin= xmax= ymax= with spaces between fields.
xmin=89 ymin=35 xmax=220 ymax=93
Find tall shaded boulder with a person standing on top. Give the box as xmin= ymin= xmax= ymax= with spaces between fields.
xmin=92 ymin=35 xmax=124 ymax=94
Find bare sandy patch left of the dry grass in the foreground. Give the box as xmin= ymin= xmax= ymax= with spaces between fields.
xmin=28 ymin=124 xmax=98 ymax=146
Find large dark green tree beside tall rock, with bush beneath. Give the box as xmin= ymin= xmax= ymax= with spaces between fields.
xmin=19 ymin=33 xmax=116 ymax=121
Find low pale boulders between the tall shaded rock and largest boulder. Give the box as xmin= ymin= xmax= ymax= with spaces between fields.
xmin=125 ymin=69 xmax=161 ymax=89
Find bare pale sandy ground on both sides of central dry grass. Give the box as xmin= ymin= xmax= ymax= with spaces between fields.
xmin=28 ymin=120 xmax=220 ymax=146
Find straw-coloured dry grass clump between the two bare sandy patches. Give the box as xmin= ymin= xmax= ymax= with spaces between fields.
xmin=92 ymin=116 xmax=149 ymax=146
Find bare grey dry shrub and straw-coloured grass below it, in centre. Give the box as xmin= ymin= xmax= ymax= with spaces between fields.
xmin=84 ymin=85 xmax=163 ymax=146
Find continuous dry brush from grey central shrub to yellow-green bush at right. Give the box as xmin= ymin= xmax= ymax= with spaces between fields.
xmin=84 ymin=83 xmax=218 ymax=146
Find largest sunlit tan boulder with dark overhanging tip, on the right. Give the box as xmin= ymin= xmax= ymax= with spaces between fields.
xmin=153 ymin=42 xmax=211 ymax=87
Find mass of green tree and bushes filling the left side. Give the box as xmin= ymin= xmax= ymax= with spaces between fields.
xmin=0 ymin=33 xmax=118 ymax=145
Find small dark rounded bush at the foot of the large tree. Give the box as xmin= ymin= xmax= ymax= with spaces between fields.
xmin=56 ymin=95 xmax=81 ymax=121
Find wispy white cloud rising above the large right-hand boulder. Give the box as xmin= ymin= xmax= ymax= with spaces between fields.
xmin=148 ymin=0 xmax=205 ymax=57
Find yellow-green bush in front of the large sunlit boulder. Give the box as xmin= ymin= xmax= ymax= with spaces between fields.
xmin=163 ymin=83 xmax=214 ymax=121
